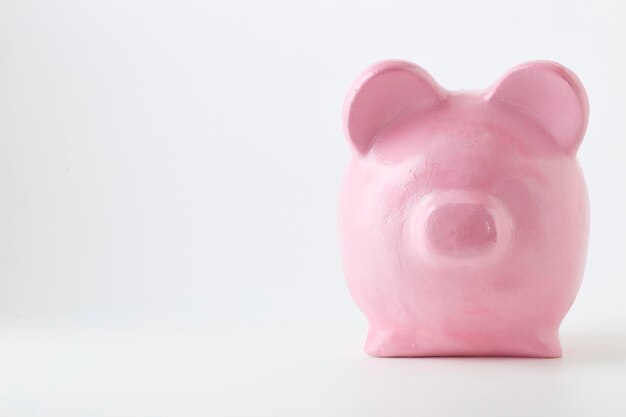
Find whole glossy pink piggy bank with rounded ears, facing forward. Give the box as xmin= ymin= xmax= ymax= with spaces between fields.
xmin=340 ymin=61 xmax=589 ymax=357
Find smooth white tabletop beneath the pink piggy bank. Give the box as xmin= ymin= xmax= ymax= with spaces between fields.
xmin=0 ymin=319 xmax=626 ymax=417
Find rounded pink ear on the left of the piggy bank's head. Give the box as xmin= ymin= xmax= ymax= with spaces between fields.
xmin=343 ymin=61 xmax=446 ymax=155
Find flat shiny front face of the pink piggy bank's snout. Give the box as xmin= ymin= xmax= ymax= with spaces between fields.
xmin=426 ymin=203 xmax=498 ymax=256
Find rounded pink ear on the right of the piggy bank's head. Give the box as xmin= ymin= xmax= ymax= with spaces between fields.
xmin=486 ymin=61 xmax=589 ymax=155
